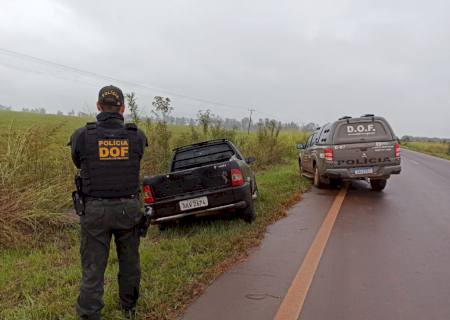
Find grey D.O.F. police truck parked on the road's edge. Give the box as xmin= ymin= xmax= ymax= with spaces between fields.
xmin=297 ymin=114 xmax=401 ymax=191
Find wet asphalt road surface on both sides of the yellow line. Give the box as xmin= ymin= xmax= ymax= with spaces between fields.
xmin=183 ymin=150 xmax=450 ymax=320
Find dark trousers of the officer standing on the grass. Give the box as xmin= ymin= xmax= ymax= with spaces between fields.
xmin=76 ymin=198 xmax=141 ymax=319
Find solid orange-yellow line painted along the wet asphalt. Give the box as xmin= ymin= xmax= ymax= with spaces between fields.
xmin=274 ymin=184 xmax=348 ymax=320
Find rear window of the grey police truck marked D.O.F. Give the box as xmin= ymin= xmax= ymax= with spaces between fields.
xmin=334 ymin=121 xmax=393 ymax=143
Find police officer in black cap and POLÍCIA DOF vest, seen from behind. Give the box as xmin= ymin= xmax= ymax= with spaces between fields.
xmin=70 ymin=86 xmax=147 ymax=319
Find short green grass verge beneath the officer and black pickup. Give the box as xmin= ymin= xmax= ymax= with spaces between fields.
xmin=0 ymin=163 xmax=309 ymax=319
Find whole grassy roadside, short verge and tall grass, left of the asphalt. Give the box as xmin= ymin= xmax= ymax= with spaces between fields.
xmin=0 ymin=112 xmax=309 ymax=319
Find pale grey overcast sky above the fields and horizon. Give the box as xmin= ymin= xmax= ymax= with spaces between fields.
xmin=0 ymin=0 xmax=450 ymax=137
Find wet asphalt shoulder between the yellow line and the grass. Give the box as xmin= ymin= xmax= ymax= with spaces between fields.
xmin=182 ymin=188 xmax=336 ymax=320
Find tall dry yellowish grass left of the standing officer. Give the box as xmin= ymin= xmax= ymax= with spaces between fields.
xmin=0 ymin=123 xmax=74 ymax=246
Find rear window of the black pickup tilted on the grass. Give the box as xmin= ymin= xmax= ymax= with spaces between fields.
xmin=172 ymin=143 xmax=234 ymax=171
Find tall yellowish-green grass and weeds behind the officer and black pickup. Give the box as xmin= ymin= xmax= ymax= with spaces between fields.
xmin=0 ymin=112 xmax=306 ymax=247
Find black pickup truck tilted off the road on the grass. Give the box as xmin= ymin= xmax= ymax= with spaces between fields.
xmin=143 ymin=139 xmax=258 ymax=229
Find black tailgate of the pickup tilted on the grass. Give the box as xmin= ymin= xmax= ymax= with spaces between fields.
xmin=151 ymin=163 xmax=230 ymax=200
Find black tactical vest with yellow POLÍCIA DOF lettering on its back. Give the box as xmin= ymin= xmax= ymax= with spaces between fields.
xmin=81 ymin=122 xmax=142 ymax=198
